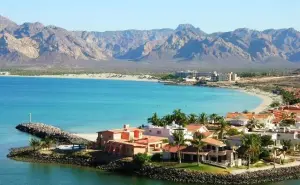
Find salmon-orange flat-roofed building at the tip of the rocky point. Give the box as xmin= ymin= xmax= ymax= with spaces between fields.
xmin=97 ymin=125 xmax=167 ymax=157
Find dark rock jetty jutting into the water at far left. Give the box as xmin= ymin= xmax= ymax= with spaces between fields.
xmin=16 ymin=123 xmax=91 ymax=144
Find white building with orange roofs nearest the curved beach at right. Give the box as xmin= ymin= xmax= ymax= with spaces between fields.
xmin=225 ymin=112 xmax=275 ymax=128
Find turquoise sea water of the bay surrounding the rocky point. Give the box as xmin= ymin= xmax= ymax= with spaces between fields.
xmin=0 ymin=77 xmax=300 ymax=185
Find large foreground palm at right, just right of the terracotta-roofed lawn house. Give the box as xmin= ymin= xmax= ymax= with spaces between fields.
xmin=242 ymin=134 xmax=261 ymax=169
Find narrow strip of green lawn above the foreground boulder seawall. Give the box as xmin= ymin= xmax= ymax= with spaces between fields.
xmin=156 ymin=162 xmax=229 ymax=174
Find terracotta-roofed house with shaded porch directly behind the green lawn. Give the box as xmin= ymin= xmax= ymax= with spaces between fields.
xmin=163 ymin=138 xmax=241 ymax=167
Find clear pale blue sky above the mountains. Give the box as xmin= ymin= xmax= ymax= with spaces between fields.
xmin=0 ymin=0 xmax=300 ymax=33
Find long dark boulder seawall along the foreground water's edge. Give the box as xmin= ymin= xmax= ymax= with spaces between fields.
xmin=8 ymin=151 xmax=300 ymax=185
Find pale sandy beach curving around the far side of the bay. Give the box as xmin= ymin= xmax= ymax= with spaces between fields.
xmin=0 ymin=73 xmax=282 ymax=113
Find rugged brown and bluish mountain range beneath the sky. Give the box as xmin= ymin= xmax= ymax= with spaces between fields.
xmin=0 ymin=16 xmax=300 ymax=68
